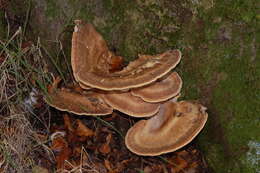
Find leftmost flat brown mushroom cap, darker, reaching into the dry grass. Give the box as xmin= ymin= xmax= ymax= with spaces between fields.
xmin=45 ymin=78 xmax=113 ymax=116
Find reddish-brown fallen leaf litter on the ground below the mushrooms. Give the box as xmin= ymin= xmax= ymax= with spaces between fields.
xmin=43 ymin=112 xmax=207 ymax=173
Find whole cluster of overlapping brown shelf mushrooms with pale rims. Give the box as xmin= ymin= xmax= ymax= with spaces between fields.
xmin=46 ymin=20 xmax=208 ymax=156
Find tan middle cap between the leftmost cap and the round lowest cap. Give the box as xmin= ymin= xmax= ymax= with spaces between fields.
xmin=103 ymin=91 xmax=160 ymax=117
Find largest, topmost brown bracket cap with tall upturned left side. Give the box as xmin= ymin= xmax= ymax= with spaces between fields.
xmin=71 ymin=21 xmax=181 ymax=90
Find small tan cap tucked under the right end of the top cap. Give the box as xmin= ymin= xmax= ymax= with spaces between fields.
xmin=131 ymin=72 xmax=182 ymax=103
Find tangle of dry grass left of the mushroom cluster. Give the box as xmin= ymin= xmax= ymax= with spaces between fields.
xmin=0 ymin=25 xmax=51 ymax=172
